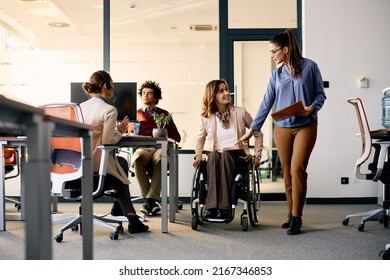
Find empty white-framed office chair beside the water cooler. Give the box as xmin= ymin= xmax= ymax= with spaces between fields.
xmin=343 ymin=98 xmax=390 ymax=231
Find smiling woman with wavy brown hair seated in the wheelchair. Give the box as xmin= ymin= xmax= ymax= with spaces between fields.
xmin=193 ymin=80 xmax=263 ymax=220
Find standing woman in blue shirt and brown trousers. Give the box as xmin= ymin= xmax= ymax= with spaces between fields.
xmin=239 ymin=30 xmax=326 ymax=235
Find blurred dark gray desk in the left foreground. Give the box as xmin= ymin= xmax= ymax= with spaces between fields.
xmin=0 ymin=95 xmax=93 ymax=259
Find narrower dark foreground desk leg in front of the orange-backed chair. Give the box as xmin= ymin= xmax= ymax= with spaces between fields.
xmin=81 ymin=134 xmax=93 ymax=260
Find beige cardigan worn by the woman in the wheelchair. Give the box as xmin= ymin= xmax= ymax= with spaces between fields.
xmin=195 ymin=106 xmax=263 ymax=157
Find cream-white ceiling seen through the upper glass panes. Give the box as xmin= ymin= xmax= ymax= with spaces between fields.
xmin=0 ymin=0 xmax=296 ymax=49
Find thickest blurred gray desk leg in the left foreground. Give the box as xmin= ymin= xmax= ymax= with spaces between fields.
xmin=24 ymin=115 xmax=54 ymax=260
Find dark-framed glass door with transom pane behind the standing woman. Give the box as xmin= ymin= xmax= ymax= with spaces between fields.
xmin=225 ymin=0 xmax=301 ymax=192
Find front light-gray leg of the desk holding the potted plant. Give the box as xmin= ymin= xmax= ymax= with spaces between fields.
xmin=160 ymin=141 xmax=168 ymax=233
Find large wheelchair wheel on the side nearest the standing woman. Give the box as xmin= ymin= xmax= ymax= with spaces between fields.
xmin=247 ymin=166 xmax=260 ymax=227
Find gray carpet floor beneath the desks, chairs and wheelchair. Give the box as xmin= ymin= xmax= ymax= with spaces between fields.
xmin=0 ymin=201 xmax=390 ymax=260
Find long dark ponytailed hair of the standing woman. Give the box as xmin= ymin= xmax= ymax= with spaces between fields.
xmin=270 ymin=29 xmax=303 ymax=78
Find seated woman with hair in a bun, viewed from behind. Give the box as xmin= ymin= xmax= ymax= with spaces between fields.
xmin=80 ymin=71 xmax=149 ymax=233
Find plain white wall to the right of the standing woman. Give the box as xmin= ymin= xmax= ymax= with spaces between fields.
xmin=303 ymin=0 xmax=390 ymax=198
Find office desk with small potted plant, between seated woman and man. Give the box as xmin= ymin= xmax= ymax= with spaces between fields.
xmin=99 ymin=136 xmax=179 ymax=233
